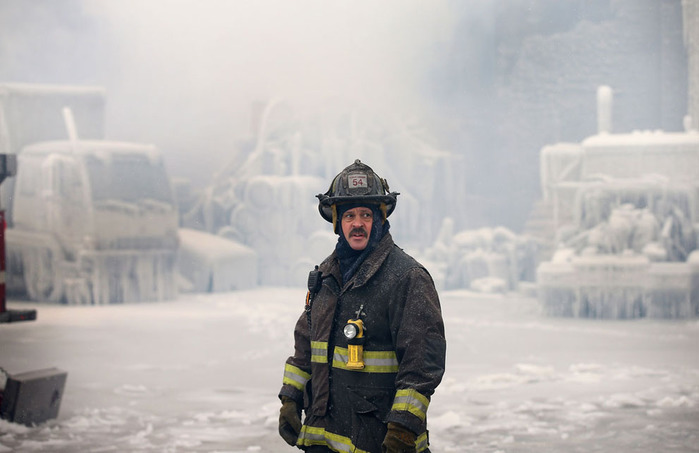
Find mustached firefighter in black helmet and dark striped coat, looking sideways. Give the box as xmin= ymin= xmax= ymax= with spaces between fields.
xmin=279 ymin=160 xmax=446 ymax=453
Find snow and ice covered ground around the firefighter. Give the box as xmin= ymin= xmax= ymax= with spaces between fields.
xmin=0 ymin=287 xmax=699 ymax=453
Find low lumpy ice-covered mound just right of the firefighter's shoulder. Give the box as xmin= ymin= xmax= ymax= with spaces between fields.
xmin=424 ymin=218 xmax=538 ymax=292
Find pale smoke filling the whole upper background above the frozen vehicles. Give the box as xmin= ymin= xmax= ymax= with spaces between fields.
xmin=0 ymin=0 xmax=687 ymax=229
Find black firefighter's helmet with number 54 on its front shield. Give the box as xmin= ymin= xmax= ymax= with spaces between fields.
xmin=316 ymin=159 xmax=399 ymax=233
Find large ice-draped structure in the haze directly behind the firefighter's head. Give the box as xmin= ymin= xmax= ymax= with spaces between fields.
xmin=183 ymin=100 xmax=464 ymax=285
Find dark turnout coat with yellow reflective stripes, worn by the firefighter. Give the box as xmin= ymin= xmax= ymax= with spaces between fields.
xmin=279 ymin=233 xmax=446 ymax=453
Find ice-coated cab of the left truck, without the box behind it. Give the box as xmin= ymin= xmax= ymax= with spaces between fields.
xmin=6 ymin=141 xmax=178 ymax=304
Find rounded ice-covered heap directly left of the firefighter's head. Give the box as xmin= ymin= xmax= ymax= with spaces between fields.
xmin=186 ymin=175 xmax=336 ymax=285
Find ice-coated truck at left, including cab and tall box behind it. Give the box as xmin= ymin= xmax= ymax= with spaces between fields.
xmin=0 ymin=84 xmax=179 ymax=304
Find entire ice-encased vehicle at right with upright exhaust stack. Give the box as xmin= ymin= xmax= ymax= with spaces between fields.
xmin=537 ymin=87 xmax=699 ymax=319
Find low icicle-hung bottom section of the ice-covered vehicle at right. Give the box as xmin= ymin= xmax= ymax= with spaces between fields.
xmin=538 ymin=249 xmax=699 ymax=319
